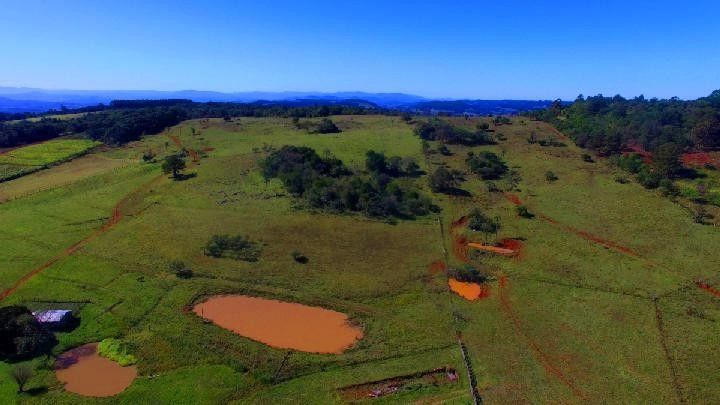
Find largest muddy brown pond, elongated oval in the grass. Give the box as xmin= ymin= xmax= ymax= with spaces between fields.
xmin=193 ymin=295 xmax=363 ymax=354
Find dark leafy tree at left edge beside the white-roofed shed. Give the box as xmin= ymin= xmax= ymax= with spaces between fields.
xmin=0 ymin=306 xmax=57 ymax=360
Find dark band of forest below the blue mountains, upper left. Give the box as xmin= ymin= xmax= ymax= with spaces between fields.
xmin=0 ymin=100 xmax=380 ymax=147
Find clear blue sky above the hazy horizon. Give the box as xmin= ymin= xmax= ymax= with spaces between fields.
xmin=0 ymin=0 xmax=720 ymax=99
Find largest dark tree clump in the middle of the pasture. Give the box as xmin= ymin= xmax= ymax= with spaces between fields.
xmin=263 ymin=146 xmax=434 ymax=218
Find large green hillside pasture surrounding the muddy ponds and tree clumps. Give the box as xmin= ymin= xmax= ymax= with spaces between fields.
xmin=0 ymin=116 xmax=720 ymax=404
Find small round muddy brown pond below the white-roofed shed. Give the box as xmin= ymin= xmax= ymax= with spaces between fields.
xmin=55 ymin=343 xmax=137 ymax=397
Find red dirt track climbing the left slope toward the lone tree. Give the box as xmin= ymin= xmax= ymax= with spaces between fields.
xmin=0 ymin=131 xmax=199 ymax=301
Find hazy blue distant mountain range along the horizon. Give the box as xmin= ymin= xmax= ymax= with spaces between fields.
xmin=0 ymin=87 xmax=551 ymax=115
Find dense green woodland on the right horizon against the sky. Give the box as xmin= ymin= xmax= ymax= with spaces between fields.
xmin=531 ymin=90 xmax=720 ymax=155
